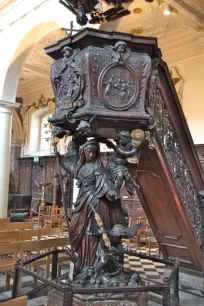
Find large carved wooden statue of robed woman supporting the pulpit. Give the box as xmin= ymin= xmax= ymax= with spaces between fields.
xmin=58 ymin=139 xmax=127 ymax=270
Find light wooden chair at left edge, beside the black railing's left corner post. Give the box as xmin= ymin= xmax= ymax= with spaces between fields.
xmin=0 ymin=242 xmax=22 ymax=289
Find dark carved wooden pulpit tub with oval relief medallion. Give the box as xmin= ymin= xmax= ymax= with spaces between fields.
xmin=47 ymin=30 xmax=151 ymax=134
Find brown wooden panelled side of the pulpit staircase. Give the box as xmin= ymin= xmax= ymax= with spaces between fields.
xmin=135 ymin=142 xmax=202 ymax=270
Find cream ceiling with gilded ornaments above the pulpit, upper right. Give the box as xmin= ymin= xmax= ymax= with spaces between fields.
xmin=102 ymin=0 xmax=204 ymax=36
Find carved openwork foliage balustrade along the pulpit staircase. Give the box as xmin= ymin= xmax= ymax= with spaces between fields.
xmin=148 ymin=59 xmax=203 ymax=246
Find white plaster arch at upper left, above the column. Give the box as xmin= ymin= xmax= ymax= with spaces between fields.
xmin=0 ymin=0 xmax=75 ymax=102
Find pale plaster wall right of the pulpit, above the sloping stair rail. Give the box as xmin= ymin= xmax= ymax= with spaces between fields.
xmin=158 ymin=32 xmax=204 ymax=144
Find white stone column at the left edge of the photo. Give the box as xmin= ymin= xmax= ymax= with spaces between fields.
xmin=0 ymin=100 xmax=19 ymax=218
